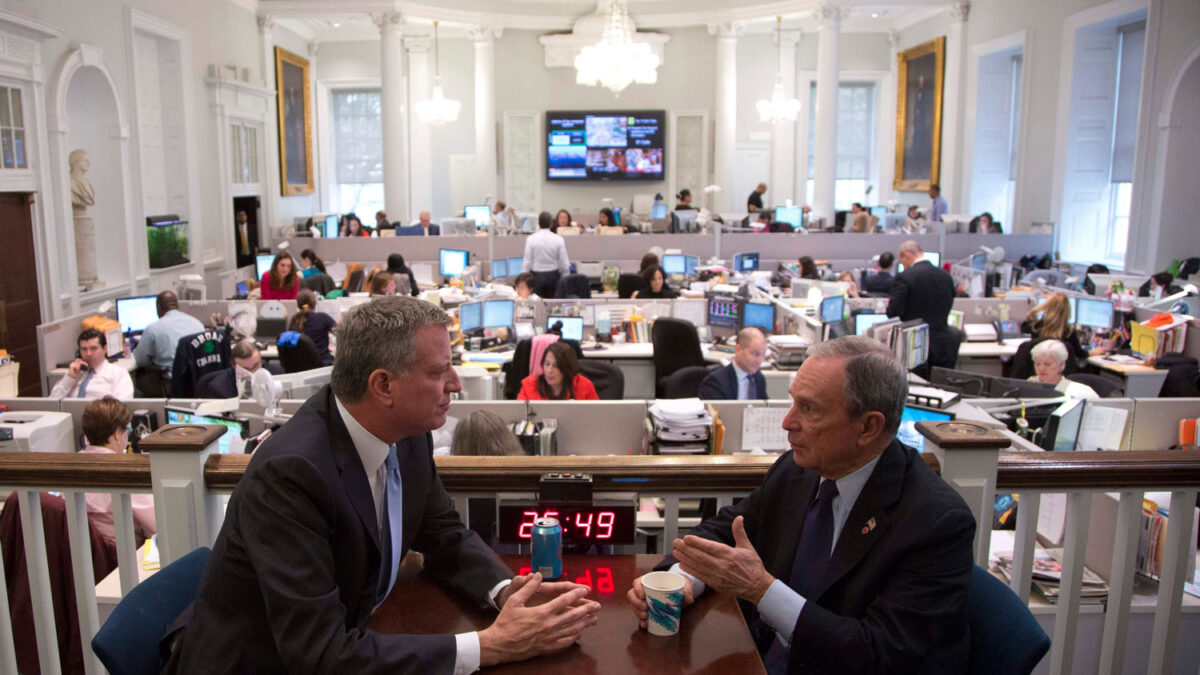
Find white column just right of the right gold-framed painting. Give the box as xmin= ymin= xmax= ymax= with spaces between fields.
xmin=938 ymin=2 xmax=971 ymax=214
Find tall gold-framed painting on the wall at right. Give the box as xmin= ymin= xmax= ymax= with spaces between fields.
xmin=892 ymin=36 xmax=946 ymax=191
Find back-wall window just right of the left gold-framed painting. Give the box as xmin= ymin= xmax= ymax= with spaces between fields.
xmin=330 ymin=89 xmax=384 ymax=222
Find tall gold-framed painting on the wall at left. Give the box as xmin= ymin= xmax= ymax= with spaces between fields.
xmin=275 ymin=47 xmax=313 ymax=197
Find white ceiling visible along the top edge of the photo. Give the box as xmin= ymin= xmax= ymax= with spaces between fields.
xmin=258 ymin=0 xmax=949 ymax=42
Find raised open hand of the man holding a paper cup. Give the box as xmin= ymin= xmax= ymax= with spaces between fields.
xmin=673 ymin=515 xmax=775 ymax=604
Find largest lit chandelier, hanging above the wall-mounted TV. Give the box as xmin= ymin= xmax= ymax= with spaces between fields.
xmin=575 ymin=0 xmax=659 ymax=94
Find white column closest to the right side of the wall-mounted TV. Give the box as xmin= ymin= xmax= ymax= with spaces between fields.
xmin=705 ymin=24 xmax=745 ymax=211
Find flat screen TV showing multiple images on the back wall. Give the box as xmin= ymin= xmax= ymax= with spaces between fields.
xmin=546 ymin=110 xmax=667 ymax=180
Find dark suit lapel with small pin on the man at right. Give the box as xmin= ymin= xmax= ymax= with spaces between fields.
xmin=816 ymin=441 xmax=908 ymax=598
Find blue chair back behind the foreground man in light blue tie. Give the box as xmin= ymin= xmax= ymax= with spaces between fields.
xmin=91 ymin=546 xmax=212 ymax=675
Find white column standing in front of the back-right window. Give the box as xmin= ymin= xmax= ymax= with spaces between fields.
xmin=812 ymin=5 xmax=841 ymax=220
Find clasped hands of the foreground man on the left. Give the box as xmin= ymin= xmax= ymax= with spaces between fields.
xmin=479 ymin=573 xmax=600 ymax=665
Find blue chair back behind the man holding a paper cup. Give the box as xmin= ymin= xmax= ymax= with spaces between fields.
xmin=966 ymin=565 xmax=1050 ymax=675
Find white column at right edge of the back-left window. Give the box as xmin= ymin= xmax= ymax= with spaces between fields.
xmin=371 ymin=12 xmax=409 ymax=225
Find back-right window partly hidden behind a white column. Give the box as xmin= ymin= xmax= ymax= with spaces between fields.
xmin=804 ymin=82 xmax=875 ymax=210
